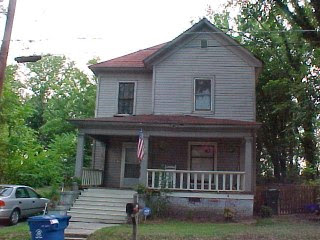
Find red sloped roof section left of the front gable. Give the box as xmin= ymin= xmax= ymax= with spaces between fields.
xmin=90 ymin=43 xmax=166 ymax=69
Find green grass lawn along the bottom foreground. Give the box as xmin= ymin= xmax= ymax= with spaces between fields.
xmin=0 ymin=216 xmax=320 ymax=240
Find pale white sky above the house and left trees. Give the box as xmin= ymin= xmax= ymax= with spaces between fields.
xmin=0 ymin=0 xmax=227 ymax=69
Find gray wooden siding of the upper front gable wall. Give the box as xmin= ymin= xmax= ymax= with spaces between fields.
xmin=153 ymin=34 xmax=255 ymax=121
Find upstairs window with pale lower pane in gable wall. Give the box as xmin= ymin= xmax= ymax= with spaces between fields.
xmin=194 ymin=79 xmax=212 ymax=111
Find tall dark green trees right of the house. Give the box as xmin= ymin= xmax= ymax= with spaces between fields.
xmin=211 ymin=0 xmax=320 ymax=182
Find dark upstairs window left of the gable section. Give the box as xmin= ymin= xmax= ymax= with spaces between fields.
xmin=118 ymin=82 xmax=135 ymax=114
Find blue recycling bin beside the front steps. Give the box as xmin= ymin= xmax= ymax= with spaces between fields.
xmin=28 ymin=215 xmax=71 ymax=240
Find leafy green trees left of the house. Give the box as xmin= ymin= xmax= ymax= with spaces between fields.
xmin=0 ymin=55 xmax=96 ymax=187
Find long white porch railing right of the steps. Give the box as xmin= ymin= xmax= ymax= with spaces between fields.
xmin=147 ymin=169 xmax=245 ymax=192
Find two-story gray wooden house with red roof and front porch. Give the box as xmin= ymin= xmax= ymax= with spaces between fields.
xmin=72 ymin=19 xmax=262 ymax=221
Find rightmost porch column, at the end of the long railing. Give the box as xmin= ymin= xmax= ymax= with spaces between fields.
xmin=244 ymin=137 xmax=253 ymax=192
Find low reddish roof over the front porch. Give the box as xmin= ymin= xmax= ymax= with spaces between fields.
xmin=71 ymin=115 xmax=260 ymax=126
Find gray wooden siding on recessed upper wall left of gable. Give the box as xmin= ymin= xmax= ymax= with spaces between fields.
xmin=96 ymin=73 xmax=152 ymax=117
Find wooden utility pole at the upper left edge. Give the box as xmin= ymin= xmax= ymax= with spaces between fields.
xmin=0 ymin=0 xmax=17 ymax=98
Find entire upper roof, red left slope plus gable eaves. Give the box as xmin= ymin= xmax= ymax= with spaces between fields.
xmin=89 ymin=18 xmax=262 ymax=73
